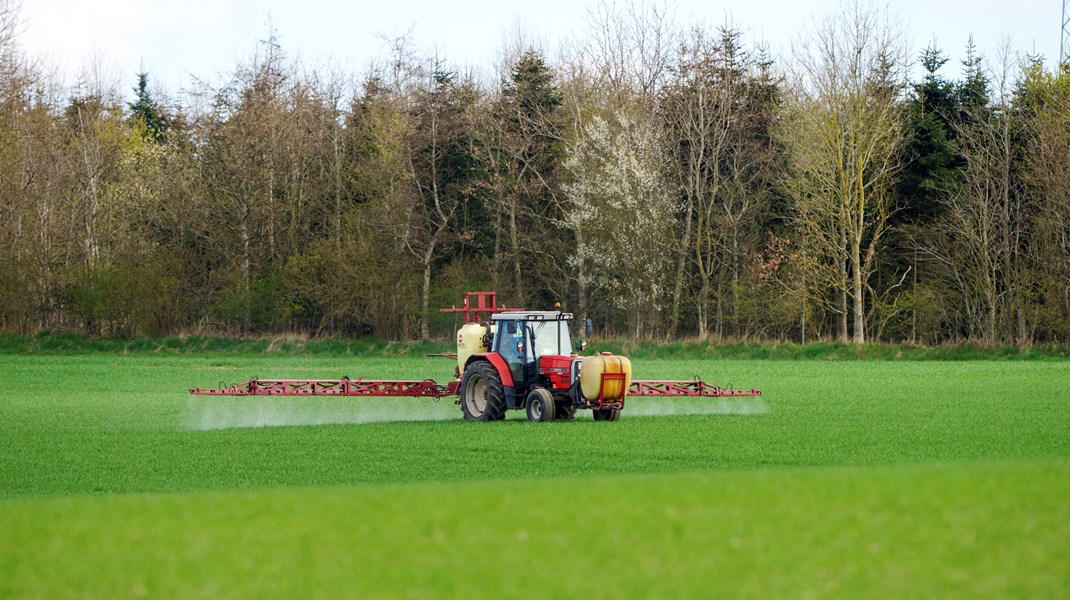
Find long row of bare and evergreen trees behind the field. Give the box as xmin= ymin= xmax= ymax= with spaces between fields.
xmin=0 ymin=0 xmax=1070 ymax=344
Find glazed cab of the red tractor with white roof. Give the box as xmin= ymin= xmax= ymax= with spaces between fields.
xmin=491 ymin=311 xmax=572 ymax=385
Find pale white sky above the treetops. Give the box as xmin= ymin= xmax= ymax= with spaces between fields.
xmin=18 ymin=0 xmax=1063 ymax=94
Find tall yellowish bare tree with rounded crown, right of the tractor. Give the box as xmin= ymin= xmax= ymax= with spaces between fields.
xmin=783 ymin=0 xmax=910 ymax=343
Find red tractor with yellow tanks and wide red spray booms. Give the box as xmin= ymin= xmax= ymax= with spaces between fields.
xmin=189 ymin=292 xmax=762 ymax=422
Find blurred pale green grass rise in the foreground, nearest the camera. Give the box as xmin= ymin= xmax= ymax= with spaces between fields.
xmin=0 ymin=460 xmax=1070 ymax=598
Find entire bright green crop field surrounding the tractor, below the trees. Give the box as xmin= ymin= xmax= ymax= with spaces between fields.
xmin=0 ymin=353 xmax=1070 ymax=598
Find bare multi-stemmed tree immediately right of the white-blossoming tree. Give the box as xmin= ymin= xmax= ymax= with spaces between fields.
xmin=659 ymin=28 xmax=776 ymax=337
